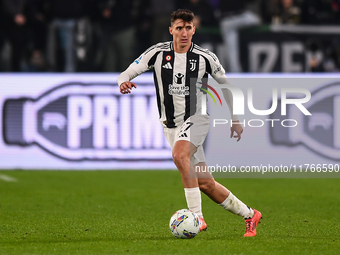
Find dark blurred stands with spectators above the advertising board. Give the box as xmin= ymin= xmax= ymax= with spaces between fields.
xmin=0 ymin=0 xmax=340 ymax=72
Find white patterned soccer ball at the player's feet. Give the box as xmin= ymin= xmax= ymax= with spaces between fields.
xmin=169 ymin=209 xmax=200 ymax=239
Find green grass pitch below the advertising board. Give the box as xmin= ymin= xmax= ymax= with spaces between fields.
xmin=0 ymin=171 xmax=340 ymax=255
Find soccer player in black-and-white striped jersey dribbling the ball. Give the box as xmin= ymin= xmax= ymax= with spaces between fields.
xmin=118 ymin=9 xmax=262 ymax=236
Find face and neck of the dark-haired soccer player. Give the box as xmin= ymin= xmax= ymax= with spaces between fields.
xmin=169 ymin=19 xmax=195 ymax=52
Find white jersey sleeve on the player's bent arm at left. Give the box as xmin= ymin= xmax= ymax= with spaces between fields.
xmin=117 ymin=44 xmax=159 ymax=86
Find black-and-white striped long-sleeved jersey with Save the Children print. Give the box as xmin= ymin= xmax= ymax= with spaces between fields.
xmin=118 ymin=42 xmax=237 ymax=128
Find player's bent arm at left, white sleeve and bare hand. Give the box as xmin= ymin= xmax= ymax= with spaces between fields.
xmin=117 ymin=45 xmax=159 ymax=94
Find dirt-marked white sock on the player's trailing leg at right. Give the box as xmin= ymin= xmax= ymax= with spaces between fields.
xmin=220 ymin=192 xmax=254 ymax=219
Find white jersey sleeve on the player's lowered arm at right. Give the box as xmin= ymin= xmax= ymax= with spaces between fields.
xmin=209 ymin=52 xmax=239 ymax=121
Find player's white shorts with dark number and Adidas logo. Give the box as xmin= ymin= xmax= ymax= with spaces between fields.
xmin=163 ymin=115 xmax=210 ymax=165
